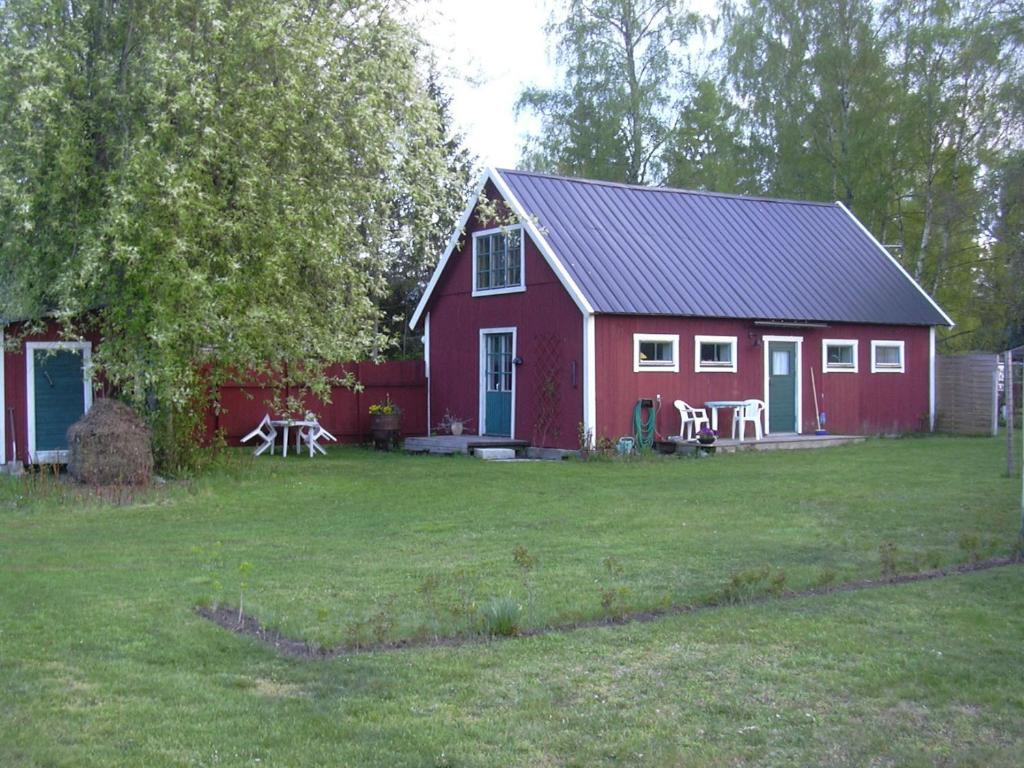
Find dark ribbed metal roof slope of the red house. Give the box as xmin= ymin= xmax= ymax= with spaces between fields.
xmin=499 ymin=170 xmax=949 ymax=326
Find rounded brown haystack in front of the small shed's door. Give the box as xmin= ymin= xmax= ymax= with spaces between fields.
xmin=68 ymin=397 xmax=153 ymax=485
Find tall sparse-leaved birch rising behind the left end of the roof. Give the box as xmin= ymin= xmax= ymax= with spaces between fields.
xmin=518 ymin=0 xmax=696 ymax=183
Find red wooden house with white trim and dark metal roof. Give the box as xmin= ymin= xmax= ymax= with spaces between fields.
xmin=411 ymin=170 xmax=952 ymax=447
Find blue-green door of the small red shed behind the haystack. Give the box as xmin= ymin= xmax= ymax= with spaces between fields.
xmin=32 ymin=349 xmax=85 ymax=454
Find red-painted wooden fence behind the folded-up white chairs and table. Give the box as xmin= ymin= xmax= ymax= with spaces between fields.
xmin=206 ymin=360 xmax=427 ymax=445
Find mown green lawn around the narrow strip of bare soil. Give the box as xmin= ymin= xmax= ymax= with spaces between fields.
xmin=0 ymin=438 xmax=1024 ymax=766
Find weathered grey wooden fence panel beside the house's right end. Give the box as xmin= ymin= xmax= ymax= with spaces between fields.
xmin=935 ymin=354 xmax=998 ymax=435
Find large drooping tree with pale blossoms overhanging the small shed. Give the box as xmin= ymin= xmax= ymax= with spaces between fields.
xmin=0 ymin=0 xmax=462 ymax=466
